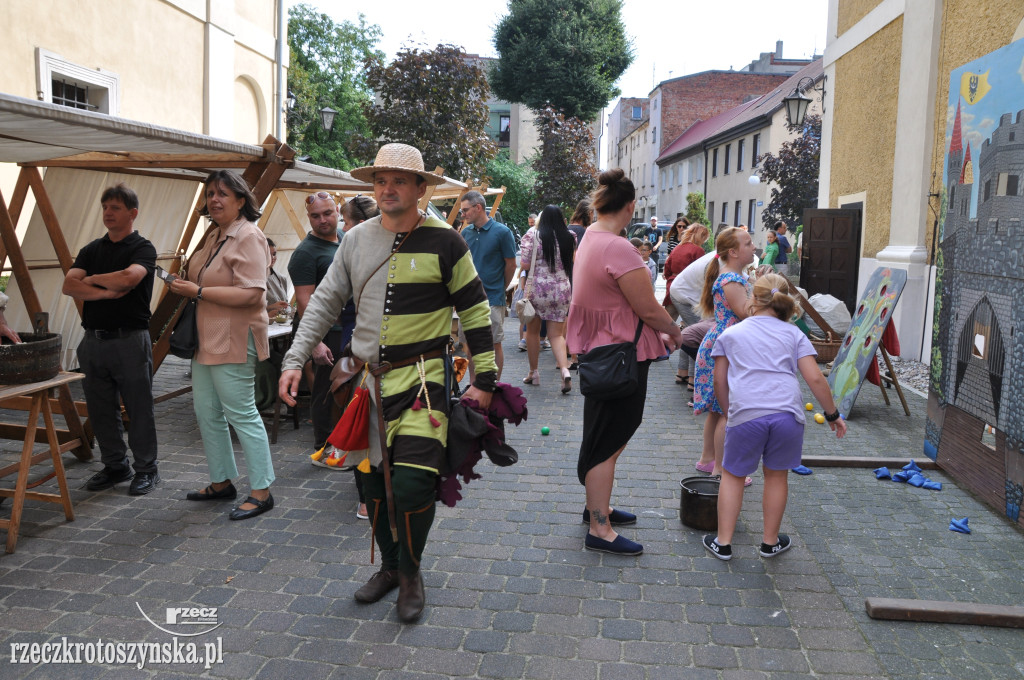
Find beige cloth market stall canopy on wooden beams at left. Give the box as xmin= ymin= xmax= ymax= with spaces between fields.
xmin=0 ymin=92 xmax=503 ymax=368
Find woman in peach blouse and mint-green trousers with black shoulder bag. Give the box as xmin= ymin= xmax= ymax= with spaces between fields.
xmin=171 ymin=170 xmax=273 ymax=519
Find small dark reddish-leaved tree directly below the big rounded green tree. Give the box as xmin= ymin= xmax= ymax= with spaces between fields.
xmin=534 ymin=107 xmax=597 ymax=209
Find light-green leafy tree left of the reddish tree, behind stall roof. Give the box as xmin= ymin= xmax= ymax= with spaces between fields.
xmin=288 ymin=4 xmax=384 ymax=170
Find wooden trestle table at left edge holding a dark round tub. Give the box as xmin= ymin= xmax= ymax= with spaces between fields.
xmin=0 ymin=371 xmax=86 ymax=553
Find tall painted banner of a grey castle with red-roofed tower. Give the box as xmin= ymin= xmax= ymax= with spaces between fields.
xmin=925 ymin=35 xmax=1024 ymax=521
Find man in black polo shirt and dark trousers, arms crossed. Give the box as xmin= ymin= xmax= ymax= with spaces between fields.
xmin=63 ymin=184 xmax=160 ymax=496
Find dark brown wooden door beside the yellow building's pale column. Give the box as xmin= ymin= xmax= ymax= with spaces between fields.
xmin=800 ymin=208 xmax=860 ymax=314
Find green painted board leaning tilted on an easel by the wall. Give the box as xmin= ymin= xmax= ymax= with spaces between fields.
xmin=828 ymin=267 xmax=906 ymax=418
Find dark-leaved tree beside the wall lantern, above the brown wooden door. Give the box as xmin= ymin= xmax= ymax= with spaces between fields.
xmin=751 ymin=114 xmax=821 ymax=230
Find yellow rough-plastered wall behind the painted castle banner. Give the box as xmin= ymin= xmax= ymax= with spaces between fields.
xmin=928 ymin=0 xmax=1024 ymax=250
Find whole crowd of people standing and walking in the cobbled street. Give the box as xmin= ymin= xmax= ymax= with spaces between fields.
xmin=12 ymin=143 xmax=846 ymax=623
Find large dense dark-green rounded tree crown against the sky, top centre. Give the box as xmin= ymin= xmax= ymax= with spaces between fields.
xmin=490 ymin=0 xmax=634 ymax=121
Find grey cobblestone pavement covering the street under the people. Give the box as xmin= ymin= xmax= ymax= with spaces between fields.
xmin=0 ymin=321 xmax=1024 ymax=680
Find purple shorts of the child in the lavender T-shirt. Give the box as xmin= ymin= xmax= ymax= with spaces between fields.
xmin=722 ymin=413 xmax=804 ymax=477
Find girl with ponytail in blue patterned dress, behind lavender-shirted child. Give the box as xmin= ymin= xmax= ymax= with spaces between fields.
xmin=693 ymin=226 xmax=754 ymax=475
